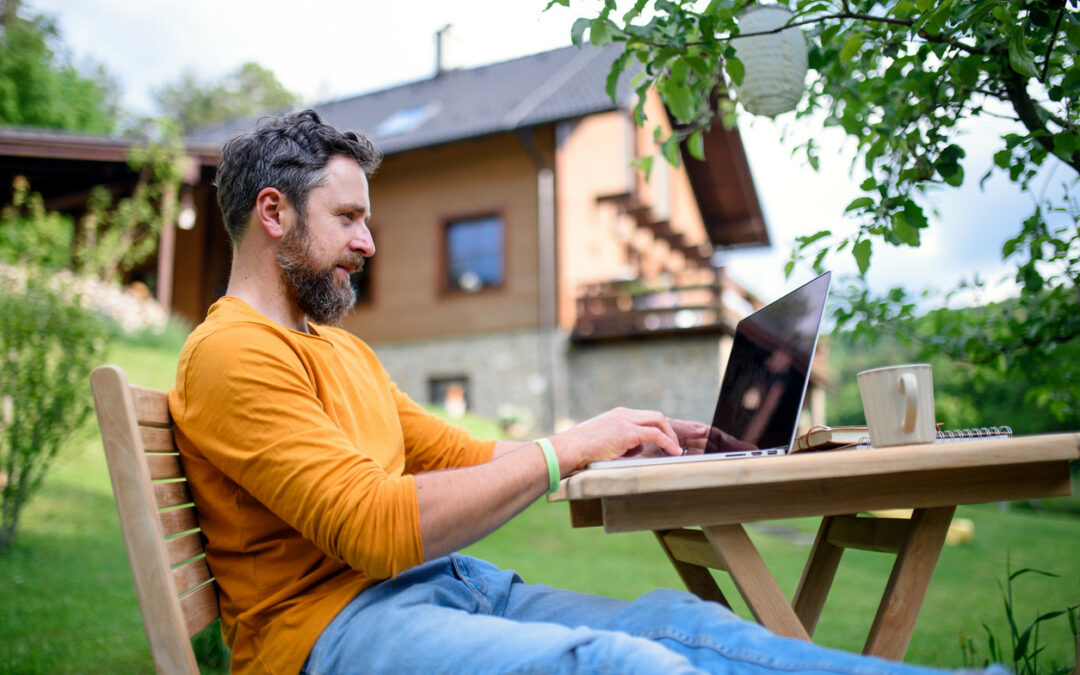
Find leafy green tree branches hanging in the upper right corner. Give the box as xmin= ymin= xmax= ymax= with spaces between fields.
xmin=548 ymin=0 xmax=1080 ymax=419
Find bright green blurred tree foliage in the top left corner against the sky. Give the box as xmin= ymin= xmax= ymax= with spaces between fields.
xmin=0 ymin=8 xmax=118 ymax=133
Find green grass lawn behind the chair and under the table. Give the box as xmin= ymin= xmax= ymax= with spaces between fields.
xmin=0 ymin=345 xmax=1080 ymax=673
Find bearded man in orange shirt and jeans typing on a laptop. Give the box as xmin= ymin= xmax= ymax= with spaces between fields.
xmin=170 ymin=110 xmax=993 ymax=674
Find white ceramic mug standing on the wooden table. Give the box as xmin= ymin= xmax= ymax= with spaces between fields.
xmin=859 ymin=363 xmax=937 ymax=447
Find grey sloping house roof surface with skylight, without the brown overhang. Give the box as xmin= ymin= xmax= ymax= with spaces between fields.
xmin=188 ymin=44 xmax=630 ymax=154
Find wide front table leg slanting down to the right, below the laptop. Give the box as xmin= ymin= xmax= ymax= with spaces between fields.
xmin=701 ymin=525 xmax=810 ymax=640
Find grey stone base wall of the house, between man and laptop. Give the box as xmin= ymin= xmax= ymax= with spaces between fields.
xmin=373 ymin=332 xmax=730 ymax=433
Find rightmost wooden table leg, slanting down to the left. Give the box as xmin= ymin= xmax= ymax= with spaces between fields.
xmin=863 ymin=507 xmax=956 ymax=661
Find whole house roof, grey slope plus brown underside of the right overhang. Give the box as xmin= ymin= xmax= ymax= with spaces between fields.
xmin=189 ymin=43 xmax=769 ymax=247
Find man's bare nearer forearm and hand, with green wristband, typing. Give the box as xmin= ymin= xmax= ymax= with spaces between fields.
xmin=416 ymin=408 xmax=708 ymax=561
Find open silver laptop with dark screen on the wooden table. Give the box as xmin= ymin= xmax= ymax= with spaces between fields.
xmin=589 ymin=272 xmax=831 ymax=469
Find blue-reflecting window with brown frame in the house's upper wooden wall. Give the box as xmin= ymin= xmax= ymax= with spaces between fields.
xmin=446 ymin=216 xmax=503 ymax=293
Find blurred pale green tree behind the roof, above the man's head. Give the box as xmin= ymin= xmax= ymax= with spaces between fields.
xmin=154 ymin=62 xmax=300 ymax=133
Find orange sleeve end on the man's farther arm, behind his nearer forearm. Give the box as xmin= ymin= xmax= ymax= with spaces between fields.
xmin=391 ymin=383 xmax=495 ymax=473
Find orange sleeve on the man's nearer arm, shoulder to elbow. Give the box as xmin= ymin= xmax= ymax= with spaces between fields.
xmin=175 ymin=325 xmax=423 ymax=579
